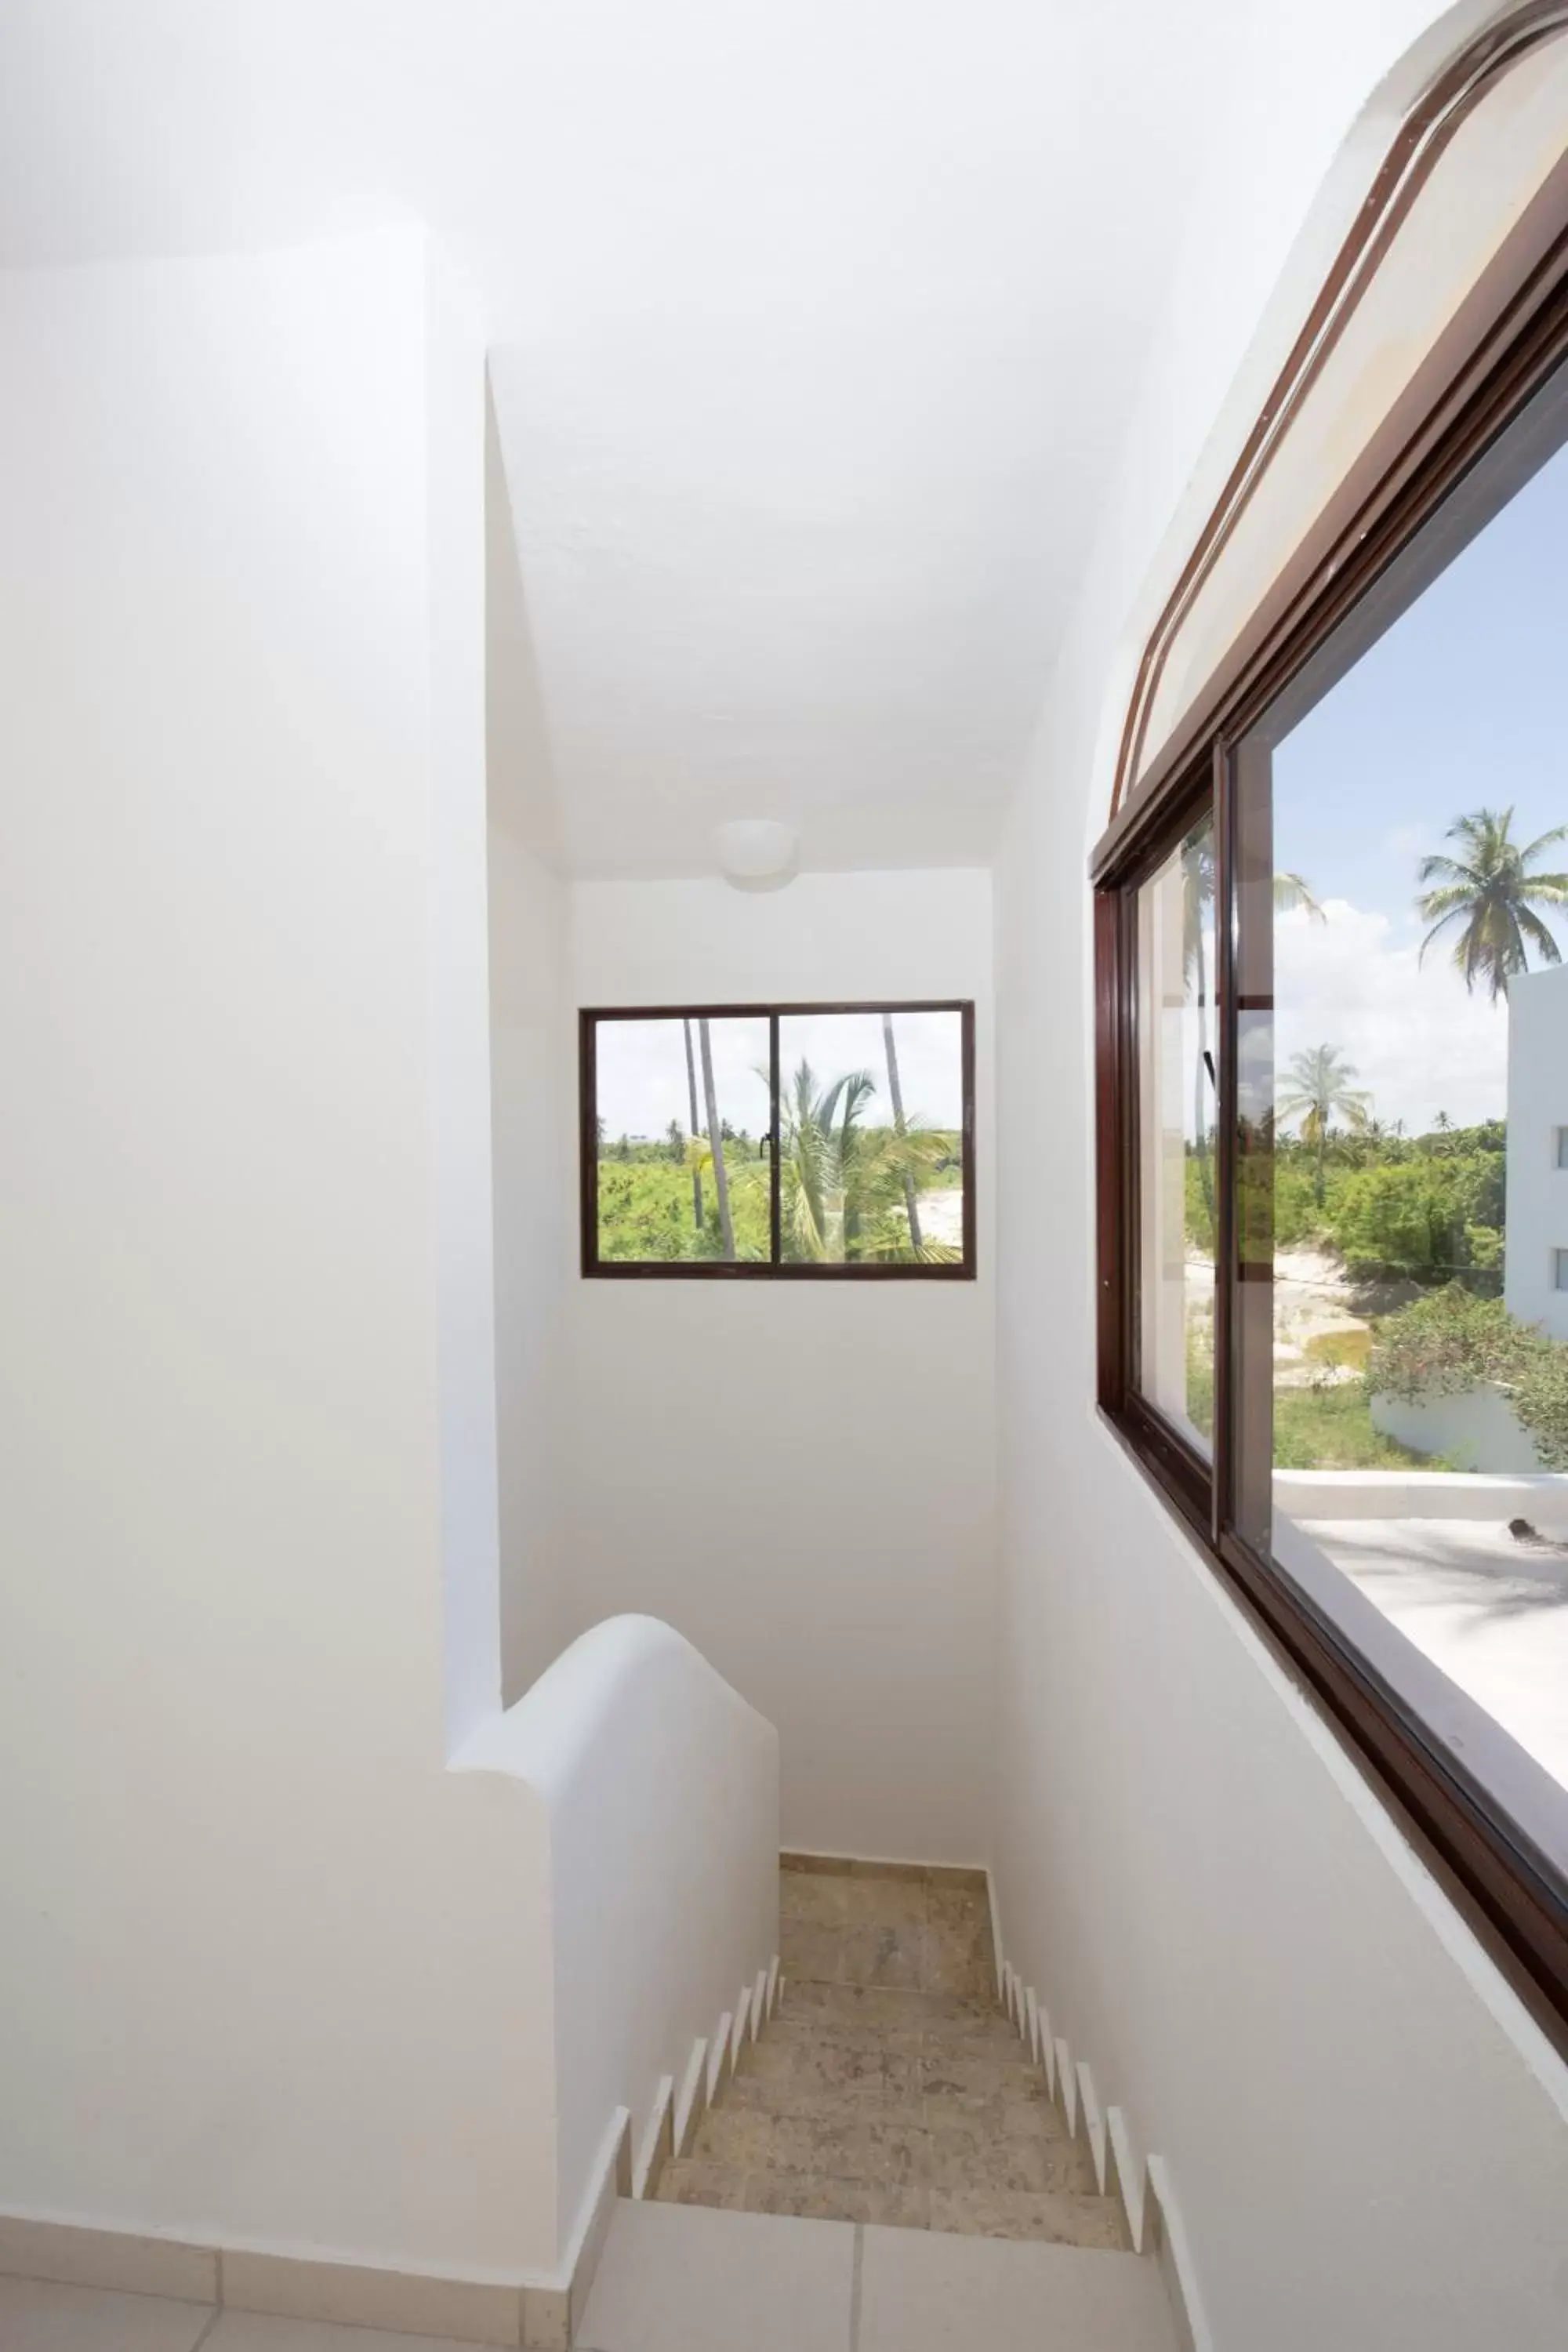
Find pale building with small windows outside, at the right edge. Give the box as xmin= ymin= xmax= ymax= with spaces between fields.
xmin=1504 ymin=964 xmax=1568 ymax=1341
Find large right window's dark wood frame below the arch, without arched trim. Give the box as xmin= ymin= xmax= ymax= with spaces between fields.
xmin=1091 ymin=228 xmax=1568 ymax=2056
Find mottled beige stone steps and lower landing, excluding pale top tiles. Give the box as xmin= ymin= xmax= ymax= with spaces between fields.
xmin=656 ymin=1863 xmax=1126 ymax=2251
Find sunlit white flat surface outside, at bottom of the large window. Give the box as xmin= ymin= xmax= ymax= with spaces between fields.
xmin=1298 ymin=1519 xmax=1568 ymax=1788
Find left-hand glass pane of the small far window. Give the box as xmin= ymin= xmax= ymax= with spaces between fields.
xmin=595 ymin=1014 xmax=771 ymax=1265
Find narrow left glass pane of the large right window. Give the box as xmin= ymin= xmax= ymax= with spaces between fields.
xmin=1138 ymin=816 xmax=1218 ymax=1454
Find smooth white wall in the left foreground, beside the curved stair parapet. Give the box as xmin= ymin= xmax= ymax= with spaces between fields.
xmin=0 ymin=235 xmax=555 ymax=2277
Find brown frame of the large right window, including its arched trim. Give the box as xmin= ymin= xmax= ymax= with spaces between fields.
xmin=1091 ymin=0 xmax=1568 ymax=2053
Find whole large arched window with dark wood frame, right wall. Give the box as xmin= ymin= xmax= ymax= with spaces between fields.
xmin=1093 ymin=5 xmax=1568 ymax=2046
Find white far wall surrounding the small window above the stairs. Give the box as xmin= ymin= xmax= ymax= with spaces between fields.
xmin=569 ymin=870 xmax=994 ymax=1863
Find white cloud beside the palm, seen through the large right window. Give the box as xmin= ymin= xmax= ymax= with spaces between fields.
xmin=1274 ymin=898 xmax=1509 ymax=1134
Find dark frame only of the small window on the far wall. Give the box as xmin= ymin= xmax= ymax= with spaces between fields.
xmin=579 ymin=997 xmax=975 ymax=1282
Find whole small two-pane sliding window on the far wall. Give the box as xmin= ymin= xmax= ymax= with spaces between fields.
xmin=581 ymin=1002 xmax=975 ymax=1279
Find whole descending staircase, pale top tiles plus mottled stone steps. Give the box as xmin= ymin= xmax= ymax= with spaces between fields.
xmin=576 ymin=1858 xmax=1178 ymax=2352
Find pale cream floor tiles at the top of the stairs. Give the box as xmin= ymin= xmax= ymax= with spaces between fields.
xmin=579 ymin=2199 xmax=1178 ymax=2352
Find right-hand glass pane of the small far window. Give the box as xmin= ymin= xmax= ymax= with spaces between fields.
xmin=779 ymin=1011 xmax=964 ymax=1272
